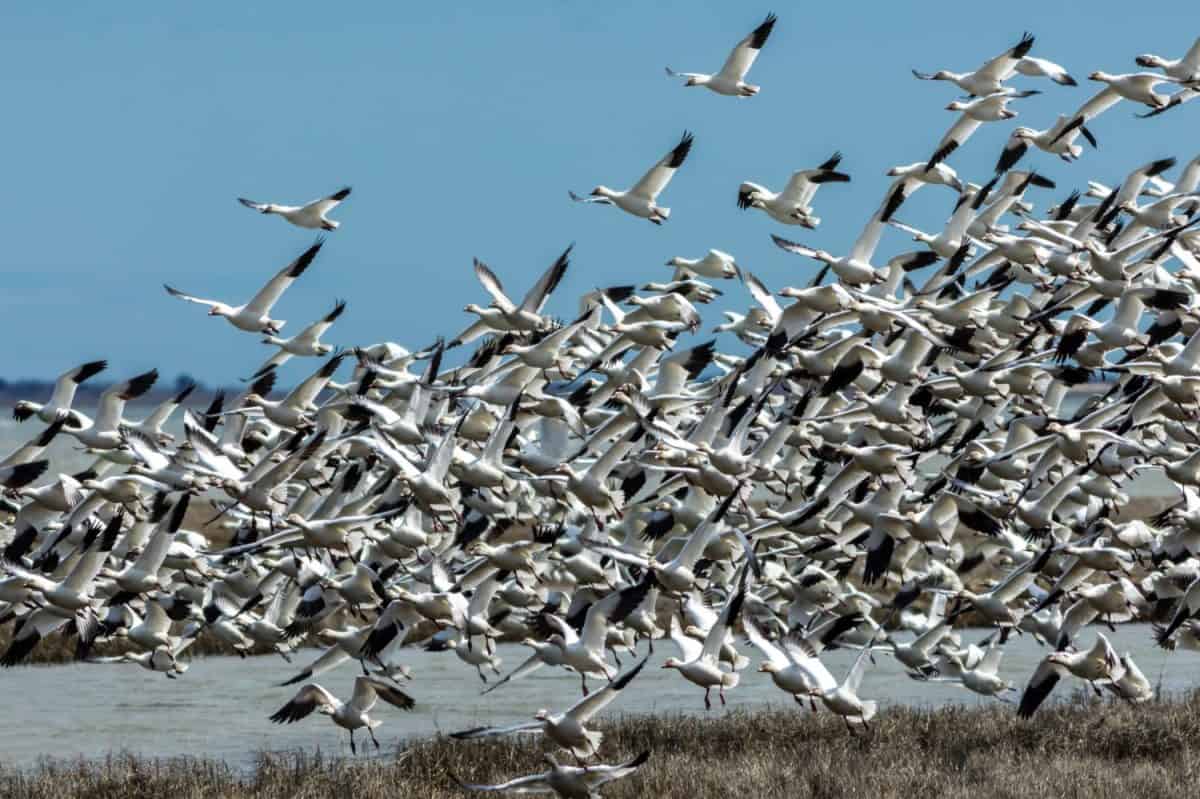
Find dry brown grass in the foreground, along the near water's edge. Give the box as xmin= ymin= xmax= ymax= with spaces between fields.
xmin=0 ymin=692 xmax=1200 ymax=799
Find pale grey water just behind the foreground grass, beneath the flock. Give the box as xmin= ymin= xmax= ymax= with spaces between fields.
xmin=0 ymin=625 xmax=1200 ymax=765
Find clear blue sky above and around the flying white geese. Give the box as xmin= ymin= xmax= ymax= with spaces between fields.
xmin=0 ymin=0 xmax=1200 ymax=382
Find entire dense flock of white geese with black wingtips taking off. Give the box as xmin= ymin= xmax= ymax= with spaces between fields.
xmin=0 ymin=16 xmax=1200 ymax=797
